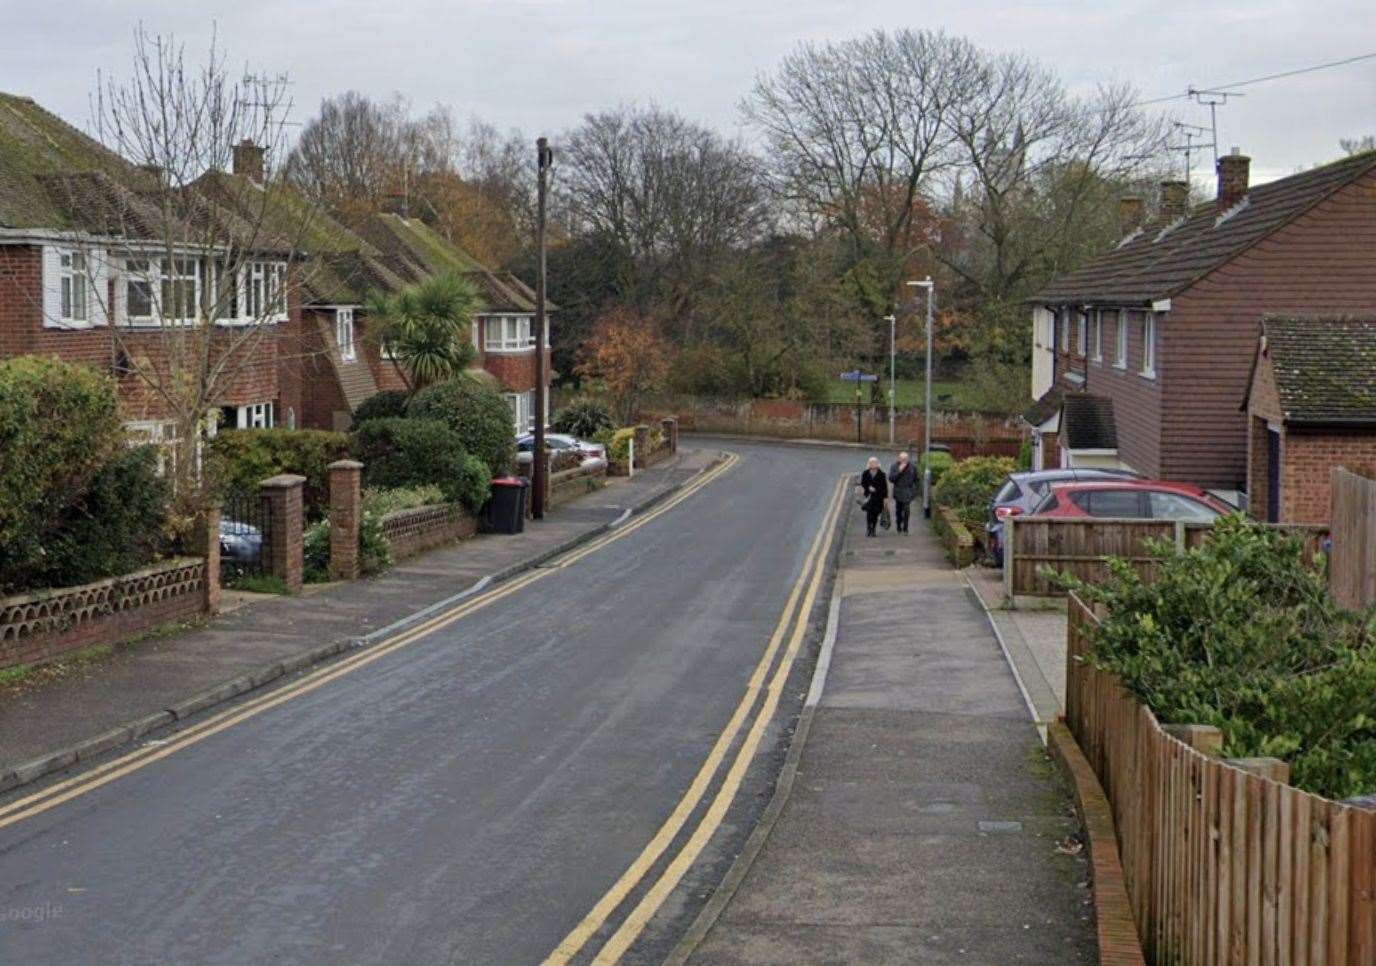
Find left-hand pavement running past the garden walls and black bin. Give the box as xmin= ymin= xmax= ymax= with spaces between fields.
xmin=0 ymin=449 xmax=717 ymax=791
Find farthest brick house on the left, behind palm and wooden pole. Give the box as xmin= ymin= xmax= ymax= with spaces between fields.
xmin=356 ymin=212 xmax=556 ymax=432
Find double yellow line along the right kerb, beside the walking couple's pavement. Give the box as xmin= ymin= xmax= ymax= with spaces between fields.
xmin=545 ymin=477 xmax=848 ymax=966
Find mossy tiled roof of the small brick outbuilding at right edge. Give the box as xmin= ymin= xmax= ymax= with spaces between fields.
xmin=1262 ymin=316 xmax=1376 ymax=425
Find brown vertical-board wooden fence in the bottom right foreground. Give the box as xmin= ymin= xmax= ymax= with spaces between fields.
xmin=1065 ymin=596 xmax=1376 ymax=966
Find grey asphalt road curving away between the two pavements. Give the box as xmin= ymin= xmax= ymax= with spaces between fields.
xmin=0 ymin=443 xmax=863 ymax=963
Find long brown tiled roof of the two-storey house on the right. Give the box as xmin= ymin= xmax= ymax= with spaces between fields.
xmin=1033 ymin=151 xmax=1376 ymax=304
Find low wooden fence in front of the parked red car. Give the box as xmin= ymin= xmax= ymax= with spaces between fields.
xmin=1003 ymin=516 xmax=1329 ymax=597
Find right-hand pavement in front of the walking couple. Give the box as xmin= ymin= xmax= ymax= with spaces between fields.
xmin=688 ymin=511 xmax=1097 ymax=965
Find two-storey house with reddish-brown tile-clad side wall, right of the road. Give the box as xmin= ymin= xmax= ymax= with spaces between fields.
xmin=1025 ymin=150 xmax=1376 ymax=498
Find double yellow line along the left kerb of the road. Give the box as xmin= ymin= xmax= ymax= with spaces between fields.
xmin=0 ymin=453 xmax=740 ymax=828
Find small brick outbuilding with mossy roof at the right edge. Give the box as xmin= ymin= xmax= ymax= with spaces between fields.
xmin=1243 ymin=316 xmax=1376 ymax=524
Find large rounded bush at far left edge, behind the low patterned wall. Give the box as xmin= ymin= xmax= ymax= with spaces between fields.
xmin=0 ymin=356 xmax=149 ymax=592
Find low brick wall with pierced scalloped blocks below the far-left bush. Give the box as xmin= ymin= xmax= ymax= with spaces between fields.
xmin=0 ymin=557 xmax=206 ymax=667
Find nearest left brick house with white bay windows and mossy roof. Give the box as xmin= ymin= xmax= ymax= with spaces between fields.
xmin=0 ymin=94 xmax=300 ymax=451
